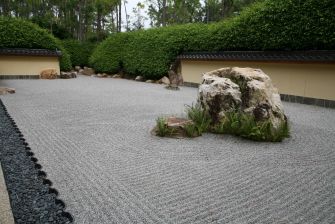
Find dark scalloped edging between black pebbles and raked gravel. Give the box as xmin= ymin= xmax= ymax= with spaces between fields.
xmin=0 ymin=99 xmax=74 ymax=223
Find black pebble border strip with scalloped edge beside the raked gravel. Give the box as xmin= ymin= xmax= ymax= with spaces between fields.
xmin=0 ymin=99 xmax=74 ymax=224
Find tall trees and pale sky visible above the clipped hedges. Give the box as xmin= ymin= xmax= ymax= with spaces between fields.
xmin=0 ymin=0 xmax=260 ymax=41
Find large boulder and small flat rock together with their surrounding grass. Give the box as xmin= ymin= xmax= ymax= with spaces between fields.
xmin=153 ymin=67 xmax=289 ymax=142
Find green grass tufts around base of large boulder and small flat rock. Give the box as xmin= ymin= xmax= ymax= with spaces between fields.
xmin=155 ymin=104 xmax=290 ymax=142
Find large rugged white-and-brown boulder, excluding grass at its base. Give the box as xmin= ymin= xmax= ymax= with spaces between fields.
xmin=198 ymin=67 xmax=287 ymax=129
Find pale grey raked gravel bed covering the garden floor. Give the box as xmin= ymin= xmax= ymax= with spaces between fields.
xmin=0 ymin=77 xmax=335 ymax=224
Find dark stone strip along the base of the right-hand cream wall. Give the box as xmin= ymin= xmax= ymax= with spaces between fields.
xmin=184 ymin=82 xmax=335 ymax=109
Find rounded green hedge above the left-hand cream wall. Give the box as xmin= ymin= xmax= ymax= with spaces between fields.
xmin=0 ymin=17 xmax=71 ymax=71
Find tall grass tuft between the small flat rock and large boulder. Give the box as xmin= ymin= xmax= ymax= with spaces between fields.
xmin=185 ymin=104 xmax=211 ymax=135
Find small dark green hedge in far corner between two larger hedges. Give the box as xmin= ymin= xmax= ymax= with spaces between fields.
xmin=62 ymin=39 xmax=96 ymax=67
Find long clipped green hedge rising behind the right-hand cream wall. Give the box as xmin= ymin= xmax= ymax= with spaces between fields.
xmin=90 ymin=0 xmax=335 ymax=79
